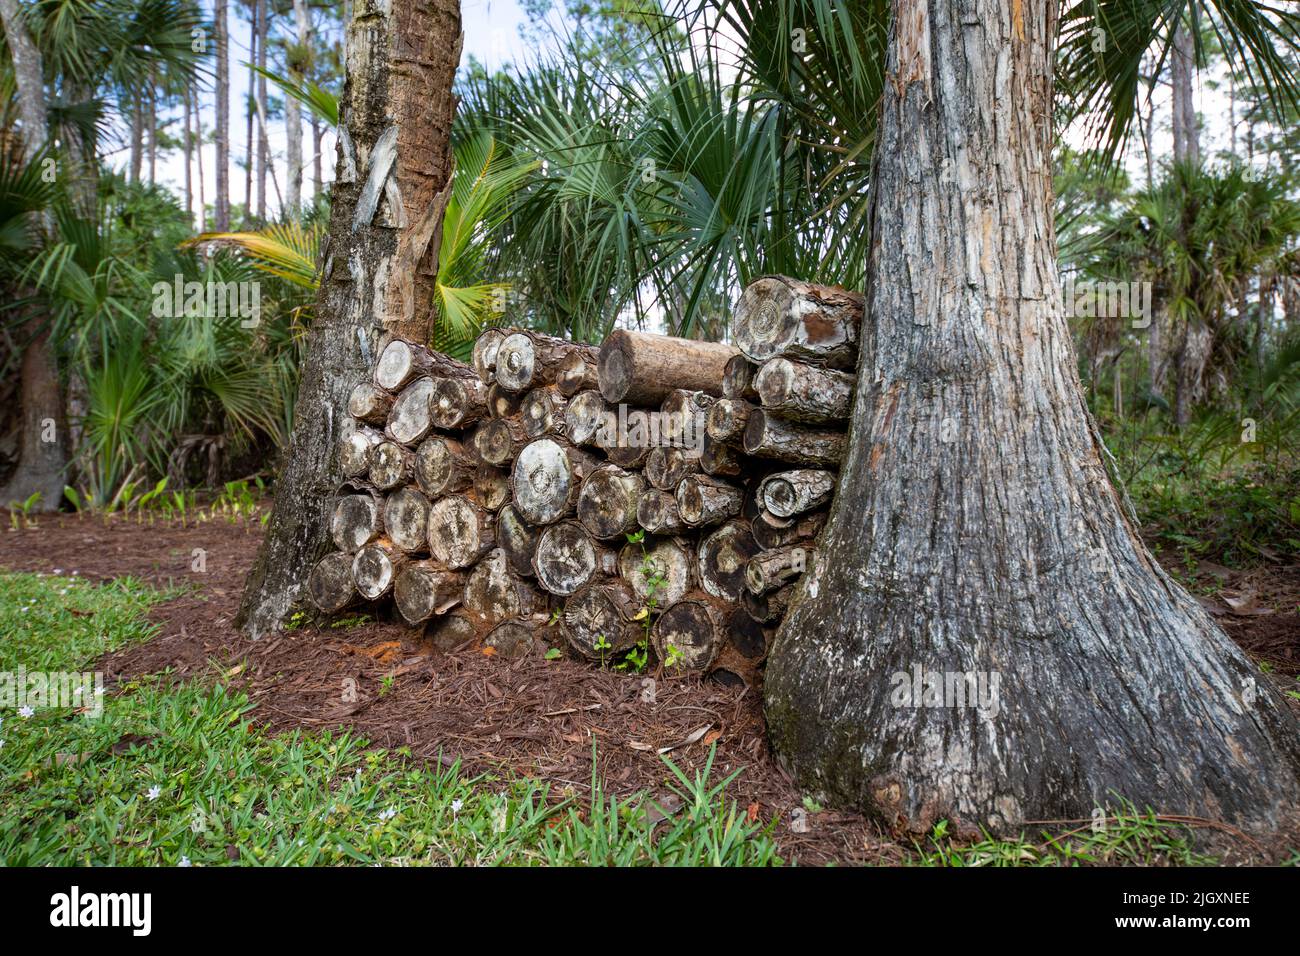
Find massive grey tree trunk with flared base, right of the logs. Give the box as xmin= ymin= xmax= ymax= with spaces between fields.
xmin=766 ymin=0 xmax=1300 ymax=832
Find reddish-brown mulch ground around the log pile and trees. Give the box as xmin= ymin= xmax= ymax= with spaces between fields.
xmin=0 ymin=515 xmax=1300 ymax=865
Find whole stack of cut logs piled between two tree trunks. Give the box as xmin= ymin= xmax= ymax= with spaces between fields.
xmin=308 ymin=277 xmax=862 ymax=682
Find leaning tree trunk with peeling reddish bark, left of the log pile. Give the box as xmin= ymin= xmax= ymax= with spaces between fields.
xmin=237 ymin=0 xmax=462 ymax=636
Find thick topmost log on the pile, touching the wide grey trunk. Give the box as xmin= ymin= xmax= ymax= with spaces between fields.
xmin=732 ymin=276 xmax=863 ymax=369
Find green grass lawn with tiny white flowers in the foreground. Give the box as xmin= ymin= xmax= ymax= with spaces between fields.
xmin=0 ymin=574 xmax=1268 ymax=866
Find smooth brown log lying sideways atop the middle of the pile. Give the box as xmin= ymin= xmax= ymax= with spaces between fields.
xmin=597 ymin=329 xmax=736 ymax=406
